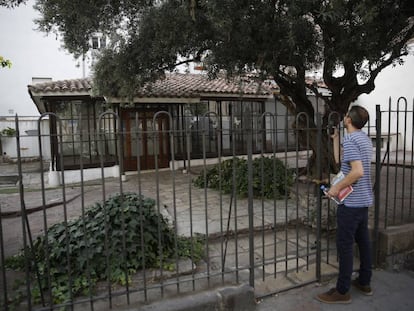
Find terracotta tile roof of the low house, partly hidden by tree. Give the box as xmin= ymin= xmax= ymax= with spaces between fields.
xmin=28 ymin=73 xmax=273 ymax=98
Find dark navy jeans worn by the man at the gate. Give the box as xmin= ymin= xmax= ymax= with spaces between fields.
xmin=336 ymin=205 xmax=372 ymax=294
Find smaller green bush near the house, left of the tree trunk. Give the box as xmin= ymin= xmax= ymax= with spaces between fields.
xmin=194 ymin=157 xmax=293 ymax=199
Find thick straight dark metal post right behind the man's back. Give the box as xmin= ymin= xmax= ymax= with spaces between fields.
xmin=372 ymin=105 xmax=381 ymax=266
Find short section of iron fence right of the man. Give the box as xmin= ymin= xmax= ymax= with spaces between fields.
xmin=374 ymin=97 xmax=414 ymax=228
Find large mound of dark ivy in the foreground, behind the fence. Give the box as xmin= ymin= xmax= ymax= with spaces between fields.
xmin=6 ymin=193 xmax=203 ymax=303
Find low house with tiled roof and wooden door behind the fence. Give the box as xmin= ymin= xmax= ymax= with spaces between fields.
xmin=28 ymin=73 xmax=295 ymax=185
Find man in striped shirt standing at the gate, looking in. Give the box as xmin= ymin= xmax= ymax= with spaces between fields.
xmin=316 ymin=106 xmax=373 ymax=303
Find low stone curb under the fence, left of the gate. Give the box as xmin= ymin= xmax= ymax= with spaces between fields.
xmin=127 ymin=284 xmax=256 ymax=311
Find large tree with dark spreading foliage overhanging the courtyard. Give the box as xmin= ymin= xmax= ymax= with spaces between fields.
xmin=36 ymin=0 xmax=414 ymax=176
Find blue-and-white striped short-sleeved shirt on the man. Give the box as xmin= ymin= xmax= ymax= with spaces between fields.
xmin=341 ymin=131 xmax=373 ymax=207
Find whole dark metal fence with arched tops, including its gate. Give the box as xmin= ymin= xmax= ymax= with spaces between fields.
xmin=0 ymin=101 xmax=413 ymax=310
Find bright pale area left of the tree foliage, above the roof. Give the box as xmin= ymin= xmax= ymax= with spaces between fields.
xmin=0 ymin=0 xmax=87 ymax=116
